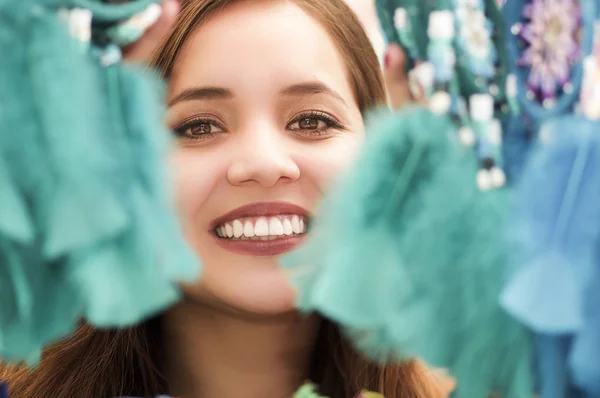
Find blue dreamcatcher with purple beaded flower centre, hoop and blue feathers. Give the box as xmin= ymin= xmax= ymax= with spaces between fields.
xmin=502 ymin=0 xmax=600 ymax=398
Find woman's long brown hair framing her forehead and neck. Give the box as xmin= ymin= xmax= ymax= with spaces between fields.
xmin=0 ymin=0 xmax=445 ymax=398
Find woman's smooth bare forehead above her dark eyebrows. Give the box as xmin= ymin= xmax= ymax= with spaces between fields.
xmin=169 ymin=0 xmax=351 ymax=101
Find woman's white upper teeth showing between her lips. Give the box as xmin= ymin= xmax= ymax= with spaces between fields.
xmin=215 ymin=215 xmax=306 ymax=239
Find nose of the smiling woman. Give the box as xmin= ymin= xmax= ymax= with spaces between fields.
xmin=227 ymin=126 xmax=300 ymax=188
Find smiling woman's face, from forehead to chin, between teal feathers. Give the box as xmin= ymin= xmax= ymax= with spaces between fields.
xmin=168 ymin=0 xmax=365 ymax=315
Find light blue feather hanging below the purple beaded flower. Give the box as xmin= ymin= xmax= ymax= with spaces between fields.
xmin=503 ymin=116 xmax=600 ymax=333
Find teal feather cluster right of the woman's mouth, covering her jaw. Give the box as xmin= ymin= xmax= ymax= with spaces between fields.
xmin=283 ymin=108 xmax=532 ymax=398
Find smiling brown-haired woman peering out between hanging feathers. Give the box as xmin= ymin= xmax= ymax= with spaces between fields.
xmin=0 ymin=0 xmax=449 ymax=398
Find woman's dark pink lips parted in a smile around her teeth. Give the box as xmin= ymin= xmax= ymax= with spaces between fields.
xmin=210 ymin=202 xmax=308 ymax=256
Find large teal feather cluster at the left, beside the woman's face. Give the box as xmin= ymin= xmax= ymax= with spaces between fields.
xmin=0 ymin=0 xmax=200 ymax=364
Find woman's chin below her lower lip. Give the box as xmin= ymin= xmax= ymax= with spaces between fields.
xmin=183 ymin=264 xmax=296 ymax=316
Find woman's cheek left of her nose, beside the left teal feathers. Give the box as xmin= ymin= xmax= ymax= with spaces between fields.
xmin=169 ymin=148 xmax=227 ymax=224
